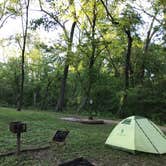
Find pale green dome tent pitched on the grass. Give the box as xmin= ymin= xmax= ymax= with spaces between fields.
xmin=106 ymin=116 xmax=166 ymax=154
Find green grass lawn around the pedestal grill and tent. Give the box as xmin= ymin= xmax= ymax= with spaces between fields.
xmin=0 ymin=108 xmax=166 ymax=166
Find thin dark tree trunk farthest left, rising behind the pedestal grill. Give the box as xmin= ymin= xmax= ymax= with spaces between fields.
xmin=17 ymin=0 xmax=30 ymax=111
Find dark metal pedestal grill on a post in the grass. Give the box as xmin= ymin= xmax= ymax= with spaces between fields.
xmin=9 ymin=121 xmax=27 ymax=155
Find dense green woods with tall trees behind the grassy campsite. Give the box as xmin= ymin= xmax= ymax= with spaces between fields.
xmin=0 ymin=0 xmax=166 ymax=122
